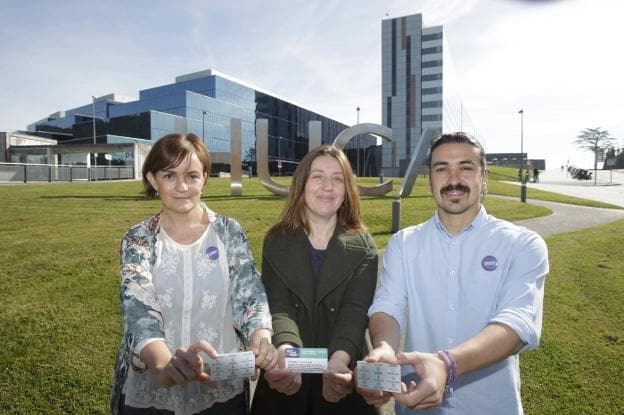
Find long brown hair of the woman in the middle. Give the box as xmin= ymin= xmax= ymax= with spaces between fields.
xmin=269 ymin=145 xmax=364 ymax=234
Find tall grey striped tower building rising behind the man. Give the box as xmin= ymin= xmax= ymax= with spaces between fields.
xmin=381 ymin=14 xmax=463 ymax=177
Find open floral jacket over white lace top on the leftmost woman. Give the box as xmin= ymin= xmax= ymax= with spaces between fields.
xmin=111 ymin=203 xmax=271 ymax=414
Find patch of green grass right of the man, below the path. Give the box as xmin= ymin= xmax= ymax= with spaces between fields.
xmin=521 ymin=220 xmax=624 ymax=414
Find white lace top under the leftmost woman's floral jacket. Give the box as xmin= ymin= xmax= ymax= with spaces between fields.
xmin=123 ymin=212 xmax=243 ymax=415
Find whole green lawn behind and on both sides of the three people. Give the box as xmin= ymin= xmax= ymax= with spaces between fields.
xmin=0 ymin=177 xmax=624 ymax=414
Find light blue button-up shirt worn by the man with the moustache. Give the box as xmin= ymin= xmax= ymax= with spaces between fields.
xmin=368 ymin=207 xmax=548 ymax=415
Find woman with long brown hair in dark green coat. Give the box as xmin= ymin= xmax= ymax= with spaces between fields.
xmin=251 ymin=145 xmax=377 ymax=415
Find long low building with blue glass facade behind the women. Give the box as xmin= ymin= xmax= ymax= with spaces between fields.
xmin=29 ymin=70 xmax=376 ymax=174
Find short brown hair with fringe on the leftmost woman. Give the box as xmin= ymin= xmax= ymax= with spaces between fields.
xmin=142 ymin=133 xmax=210 ymax=198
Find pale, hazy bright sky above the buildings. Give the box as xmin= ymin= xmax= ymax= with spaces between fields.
xmin=0 ymin=0 xmax=624 ymax=169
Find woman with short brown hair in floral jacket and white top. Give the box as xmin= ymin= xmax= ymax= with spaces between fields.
xmin=111 ymin=134 xmax=277 ymax=414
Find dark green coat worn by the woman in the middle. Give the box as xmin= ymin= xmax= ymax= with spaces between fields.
xmin=251 ymin=226 xmax=377 ymax=415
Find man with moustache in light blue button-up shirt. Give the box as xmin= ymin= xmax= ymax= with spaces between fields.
xmin=360 ymin=133 xmax=548 ymax=415
